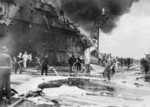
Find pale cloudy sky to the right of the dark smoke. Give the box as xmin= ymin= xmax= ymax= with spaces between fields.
xmin=100 ymin=0 xmax=150 ymax=59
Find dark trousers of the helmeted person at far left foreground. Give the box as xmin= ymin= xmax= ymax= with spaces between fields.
xmin=0 ymin=68 xmax=11 ymax=99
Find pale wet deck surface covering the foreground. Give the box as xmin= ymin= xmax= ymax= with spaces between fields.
xmin=4 ymin=65 xmax=150 ymax=107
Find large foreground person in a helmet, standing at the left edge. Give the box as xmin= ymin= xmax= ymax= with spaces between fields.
xmin=0 ymin=46 xmax=12 ymax=103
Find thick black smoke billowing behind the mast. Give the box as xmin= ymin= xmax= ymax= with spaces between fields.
xmin=61 ymin=0 xmax=139 ymax=33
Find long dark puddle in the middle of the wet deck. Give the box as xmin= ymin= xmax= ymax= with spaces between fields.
xmin=38 ymin=78 xmax=115 ymax=96
